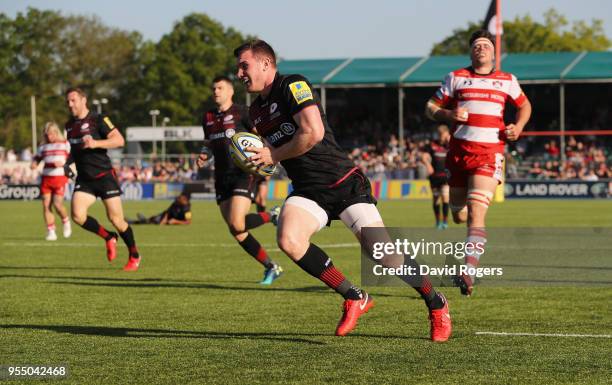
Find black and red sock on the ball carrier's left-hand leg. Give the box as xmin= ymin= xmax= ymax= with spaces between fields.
xmin=296 ymin=243 xmax=362 ymax=300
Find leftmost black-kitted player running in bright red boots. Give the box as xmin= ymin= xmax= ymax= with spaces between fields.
xmin=66 ymin=88 xmax=140 ymax=271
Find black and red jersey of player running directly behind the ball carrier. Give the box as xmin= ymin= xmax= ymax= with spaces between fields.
xmin=202 ymin=104 xmax=253 ymax=179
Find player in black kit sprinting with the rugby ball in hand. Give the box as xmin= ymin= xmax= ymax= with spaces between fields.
xmin=234 ymin=40 xmax=451 ymax=341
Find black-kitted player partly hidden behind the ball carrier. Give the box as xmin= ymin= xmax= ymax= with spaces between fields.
xmin=197 ymin=76 xmax=283 ymax=285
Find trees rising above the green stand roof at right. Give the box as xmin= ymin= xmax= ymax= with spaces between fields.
xmin=431 ymin=8 xmax=612 ymax=55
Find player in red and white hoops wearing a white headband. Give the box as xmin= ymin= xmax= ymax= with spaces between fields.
xmin=426 ymin=30 xmax=531 ymax=295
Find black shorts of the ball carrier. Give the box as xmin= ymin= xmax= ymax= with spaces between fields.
xmin=287 ymin=169 xmax=377 ymax=226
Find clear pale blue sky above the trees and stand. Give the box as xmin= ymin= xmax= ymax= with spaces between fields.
xmin=0 ymin=0 xmax=612 ymax=59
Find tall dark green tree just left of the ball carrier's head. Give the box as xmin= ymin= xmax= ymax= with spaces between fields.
xmin=121 ymin=13 xmax=252 ymax=151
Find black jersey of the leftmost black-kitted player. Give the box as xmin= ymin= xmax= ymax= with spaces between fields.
xmin=65 ymin=111 xmax=115 ymax=179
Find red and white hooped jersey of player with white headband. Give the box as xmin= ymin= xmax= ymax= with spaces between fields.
xmin=432 ymin=68 xmax=527 ymax=154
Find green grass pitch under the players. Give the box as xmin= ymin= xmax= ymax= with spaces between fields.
xmin=0 ymin=200 xmax=612 ymax=384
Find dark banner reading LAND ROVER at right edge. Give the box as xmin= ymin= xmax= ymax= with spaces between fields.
xmin=504 ymin=180 xmax=612 ymax=199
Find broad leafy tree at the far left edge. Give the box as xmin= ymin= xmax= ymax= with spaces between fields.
xmin=0 ymin=8 xmax=143 ymax=148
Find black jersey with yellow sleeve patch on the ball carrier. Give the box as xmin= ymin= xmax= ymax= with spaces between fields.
xmin=249 ymin=73 xmax=355 ymax=189
